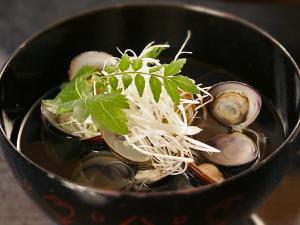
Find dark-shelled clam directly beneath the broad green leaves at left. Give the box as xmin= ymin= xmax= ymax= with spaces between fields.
xmin=41 ymin=104 xmax=108 ymax=162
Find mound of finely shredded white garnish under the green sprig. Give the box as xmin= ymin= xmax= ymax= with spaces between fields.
xmin=105 ymin=33 xmax=219 ymax=181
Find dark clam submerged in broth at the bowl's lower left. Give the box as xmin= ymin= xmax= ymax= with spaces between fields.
xmin=74 ymin=151 xmax=135 ymax=190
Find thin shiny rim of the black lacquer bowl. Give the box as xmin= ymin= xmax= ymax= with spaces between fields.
xmin=0 ymin=2 xmax=300 ymax=199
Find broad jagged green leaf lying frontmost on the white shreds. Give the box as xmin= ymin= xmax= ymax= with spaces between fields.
xmin=86 ymin=93 xmax=129 ymax=135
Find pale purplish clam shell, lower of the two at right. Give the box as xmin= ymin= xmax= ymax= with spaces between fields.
xmin=202 ymin=132 xmax=259 ymax=167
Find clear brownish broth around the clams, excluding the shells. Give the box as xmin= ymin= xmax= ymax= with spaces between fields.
xmin=18 ymin=60 xmax=284 ymax=191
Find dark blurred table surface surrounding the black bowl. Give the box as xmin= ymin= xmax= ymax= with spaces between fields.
xmin=0 ymin=0 xmax=300 ymax=225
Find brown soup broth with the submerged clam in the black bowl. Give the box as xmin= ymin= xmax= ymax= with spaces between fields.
xmin=18 ymin=60 xmax=284 ymax=191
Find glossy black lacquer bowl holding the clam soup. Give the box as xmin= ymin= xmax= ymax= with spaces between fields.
xmin=0 ymin=5 xmax=300 ymax=225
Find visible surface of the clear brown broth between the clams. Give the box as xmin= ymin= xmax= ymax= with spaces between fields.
xmin=17 ymin=60 xmax=284 ymax=191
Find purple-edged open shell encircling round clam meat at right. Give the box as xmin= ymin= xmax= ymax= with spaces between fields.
xmin=209 ymin=81 xmax=262 ymax=130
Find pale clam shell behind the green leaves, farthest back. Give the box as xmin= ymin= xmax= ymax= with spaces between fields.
xmin=69 ymin=51 xmax=116 ymax=80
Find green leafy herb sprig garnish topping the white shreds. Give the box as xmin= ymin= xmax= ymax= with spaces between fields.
xmin=43 ymin=38 xmax=199 ymax=135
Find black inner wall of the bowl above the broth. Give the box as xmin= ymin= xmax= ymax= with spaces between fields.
xmin=0 ymin=5 xmax=300 ymax=192
